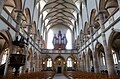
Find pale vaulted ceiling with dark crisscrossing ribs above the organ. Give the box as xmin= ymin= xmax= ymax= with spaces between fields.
xmin=40 ymin=0 xmax=80 ymax=27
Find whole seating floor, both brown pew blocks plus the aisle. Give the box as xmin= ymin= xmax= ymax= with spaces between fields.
xmin=0 ymin=71 xmax=120 ymax=79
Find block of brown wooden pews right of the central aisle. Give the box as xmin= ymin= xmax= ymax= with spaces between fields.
xmin=64 ymin=71 xmax=120 ymax=79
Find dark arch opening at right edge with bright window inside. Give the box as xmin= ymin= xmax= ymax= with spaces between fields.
xmin=108 ymin=31 xmax=120 ymax=72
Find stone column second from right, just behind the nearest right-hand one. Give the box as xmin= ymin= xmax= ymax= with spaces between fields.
xmin=90 ymin=26 xmax=99 ymax=73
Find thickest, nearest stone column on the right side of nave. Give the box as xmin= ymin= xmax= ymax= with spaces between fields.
xmin=99 ymin=10 xmax=116 ymax=75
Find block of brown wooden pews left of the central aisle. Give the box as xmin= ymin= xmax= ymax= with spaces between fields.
xmin=3 ymin=71 xmax=55 ymax=79
